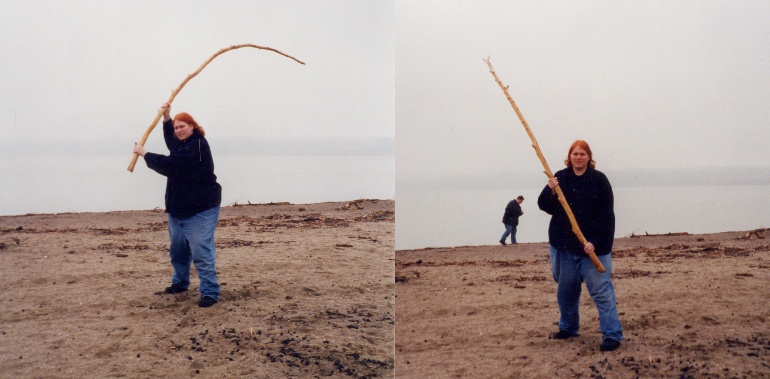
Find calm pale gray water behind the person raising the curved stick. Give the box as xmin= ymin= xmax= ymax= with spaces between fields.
xmin=0 ymin=154 xmax=395 ymax=215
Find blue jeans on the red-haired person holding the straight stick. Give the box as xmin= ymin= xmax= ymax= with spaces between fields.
xmin=551 ymin=246 xmax=623 ymax=341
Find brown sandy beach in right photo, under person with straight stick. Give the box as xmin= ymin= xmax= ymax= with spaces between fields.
xmin=396 ymin=229 xmax=770 ymax=379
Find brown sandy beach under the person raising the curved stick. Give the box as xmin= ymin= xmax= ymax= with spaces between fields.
xmin=0 ymin=200 xmax=395 ymax=378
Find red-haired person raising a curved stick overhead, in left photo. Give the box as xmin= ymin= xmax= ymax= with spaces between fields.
xmin=134 ymin=103 xmax=222 ymax=307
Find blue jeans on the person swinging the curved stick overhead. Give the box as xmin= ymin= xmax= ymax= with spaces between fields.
xmin=168 ymin=206 xmax=219 ymax=300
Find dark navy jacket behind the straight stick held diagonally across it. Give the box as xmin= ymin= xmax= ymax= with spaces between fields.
xmin=537 ymin=167 xmax=615 ymax=255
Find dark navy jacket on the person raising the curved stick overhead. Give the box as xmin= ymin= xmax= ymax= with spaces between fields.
xmin=144 ymin=120 xmax=222 ymax=219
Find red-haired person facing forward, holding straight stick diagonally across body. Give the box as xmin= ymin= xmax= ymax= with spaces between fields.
xmin=537 ymin=140 xmax=623 ymax=351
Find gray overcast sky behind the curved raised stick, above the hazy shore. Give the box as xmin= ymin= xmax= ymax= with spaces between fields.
xmin=0 ymin=0 xmax=395 ymax=154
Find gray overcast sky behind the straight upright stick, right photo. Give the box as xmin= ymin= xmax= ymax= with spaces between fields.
xmin=395 ymin=0 xmax=770 ymax=184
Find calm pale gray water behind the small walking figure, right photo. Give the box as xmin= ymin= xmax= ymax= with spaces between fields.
xmin=396 ymin=186 xmax=770 ymax=249
